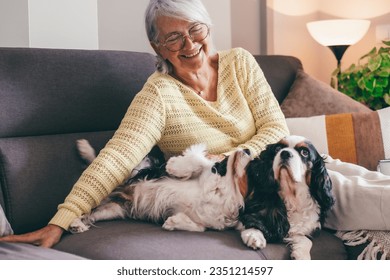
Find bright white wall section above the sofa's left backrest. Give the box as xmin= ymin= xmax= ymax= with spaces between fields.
xmin=28 ymin=0 xmax=99 ymax=49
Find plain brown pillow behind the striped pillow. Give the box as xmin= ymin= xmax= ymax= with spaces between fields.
xmin=280 ymin=70 xmax=372 ymax=118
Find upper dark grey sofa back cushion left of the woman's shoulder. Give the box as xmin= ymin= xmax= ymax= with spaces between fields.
xmin=0 ymin=48 xmax=155 ymax=137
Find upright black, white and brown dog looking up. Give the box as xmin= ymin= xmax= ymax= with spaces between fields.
xmin=240 ymin=136 xmax=334 ymax=259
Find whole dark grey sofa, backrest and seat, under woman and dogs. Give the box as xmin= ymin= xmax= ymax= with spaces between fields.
xmin=0 ymin=48 xmax=348 ymax=260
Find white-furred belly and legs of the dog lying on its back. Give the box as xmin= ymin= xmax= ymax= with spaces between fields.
xmin=70 ymin=145 xmax=250 ymax=232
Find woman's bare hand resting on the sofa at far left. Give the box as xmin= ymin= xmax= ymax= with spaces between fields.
xmin=0 ymin=225 xmax=64 ymax=248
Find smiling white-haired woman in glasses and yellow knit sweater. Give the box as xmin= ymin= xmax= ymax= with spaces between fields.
xmin=2 ymin=0 xmax=289 ymax=247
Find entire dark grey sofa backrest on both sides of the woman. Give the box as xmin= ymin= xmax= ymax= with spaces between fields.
xmin=0 ymin=48 xmax=302 ymax=233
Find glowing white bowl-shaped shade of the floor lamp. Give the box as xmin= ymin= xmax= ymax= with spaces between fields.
xmin=306 ymin=19 xmax=370 ymax=46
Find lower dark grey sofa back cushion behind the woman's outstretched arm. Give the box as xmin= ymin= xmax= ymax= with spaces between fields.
xmin=0 ymin=131 xmax=113 ymax=234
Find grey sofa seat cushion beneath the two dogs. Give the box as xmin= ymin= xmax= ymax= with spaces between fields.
xmin=55 ymin=220 xmax=347 ymax=260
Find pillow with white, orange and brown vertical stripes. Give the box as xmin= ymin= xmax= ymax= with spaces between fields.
xmin=286 ymin=107 xmax=390 ymax=170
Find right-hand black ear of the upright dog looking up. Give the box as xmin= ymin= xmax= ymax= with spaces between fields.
xmin=310 ymin=152 xmax=335 ymax=223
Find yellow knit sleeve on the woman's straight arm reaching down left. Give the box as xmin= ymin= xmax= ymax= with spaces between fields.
xmin=50 ymin=83 xmax=165 ymax=229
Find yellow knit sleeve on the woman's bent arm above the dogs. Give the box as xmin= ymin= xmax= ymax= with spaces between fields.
xmin=233 ymin=49 xmax=289 ymax=155
